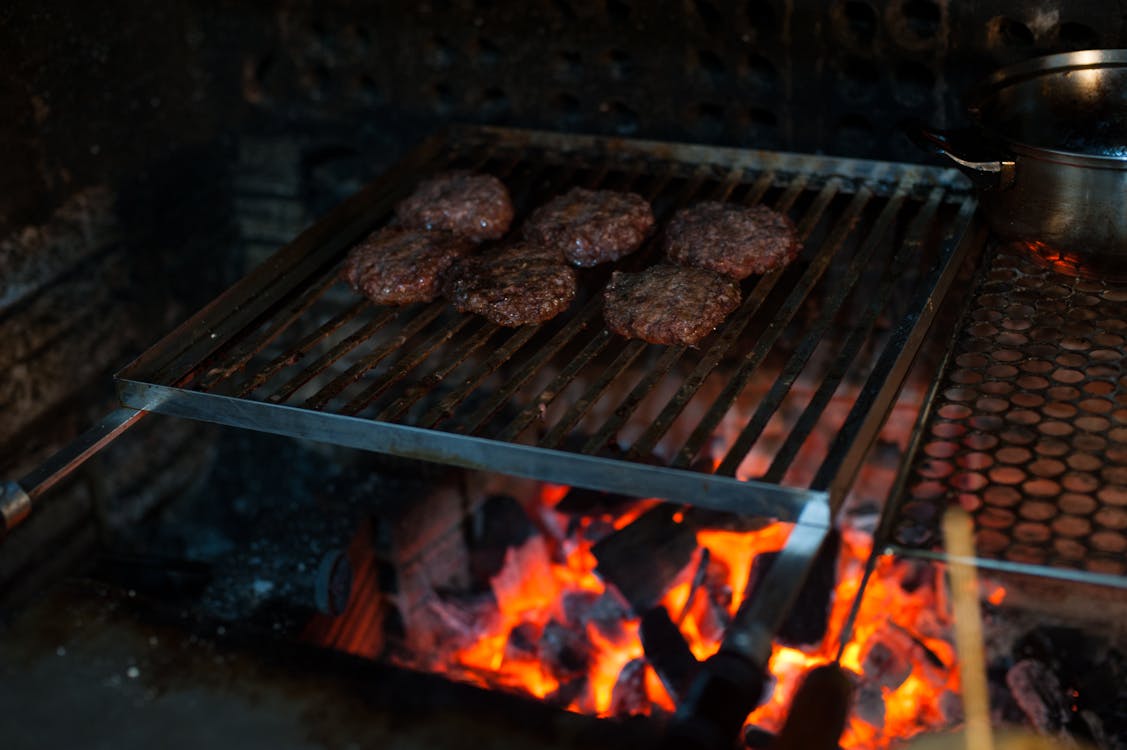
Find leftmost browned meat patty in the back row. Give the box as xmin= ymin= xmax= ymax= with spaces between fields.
xmin=396 ymin=171 xmax=513 ymax=242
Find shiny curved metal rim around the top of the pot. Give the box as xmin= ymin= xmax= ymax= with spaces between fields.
xmin=966 ymin=48 xmax=1127 ymax=169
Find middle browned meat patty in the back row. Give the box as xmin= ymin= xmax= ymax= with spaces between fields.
xmin=524 ymin=187 xmax=654 ymax=267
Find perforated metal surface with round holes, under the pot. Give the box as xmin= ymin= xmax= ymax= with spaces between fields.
xmin=891 ymin=246 xmax=1127 ymax=585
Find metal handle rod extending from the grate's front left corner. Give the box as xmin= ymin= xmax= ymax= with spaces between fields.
xmin=0 ymin=406 xmax=148 ymax=537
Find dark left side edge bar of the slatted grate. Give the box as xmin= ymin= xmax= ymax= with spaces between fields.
xmin=118 ymin=133 xmax=457 ymax=381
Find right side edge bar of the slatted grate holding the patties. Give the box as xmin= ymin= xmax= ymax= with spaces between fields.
xmin=810 ymin=197 xmax=986 ymax=511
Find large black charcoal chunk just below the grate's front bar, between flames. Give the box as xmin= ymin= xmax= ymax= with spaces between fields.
xmin=592 ymin=503 xmax=696 ymax=612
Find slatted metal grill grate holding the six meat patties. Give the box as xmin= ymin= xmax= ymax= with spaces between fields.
xmin=118 ymin=129 xmax=975 ymax=520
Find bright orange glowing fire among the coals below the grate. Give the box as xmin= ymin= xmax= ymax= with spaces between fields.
xmin=385 ymin=486 xmax=978 ymax=749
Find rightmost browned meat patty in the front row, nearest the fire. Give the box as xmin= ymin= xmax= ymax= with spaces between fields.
xmin=603 ymin=265 xmax=739 ymax=346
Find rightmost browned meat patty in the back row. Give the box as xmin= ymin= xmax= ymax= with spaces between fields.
xmin=663 ymin=201 xmax=802 ymax=279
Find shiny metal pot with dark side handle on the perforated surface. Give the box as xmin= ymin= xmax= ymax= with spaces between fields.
xmin=908 ymin=50 xmax=1127 ymax=276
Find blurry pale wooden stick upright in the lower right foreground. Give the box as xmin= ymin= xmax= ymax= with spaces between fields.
xmin=943 ymin=505 xmax=994 ymax=750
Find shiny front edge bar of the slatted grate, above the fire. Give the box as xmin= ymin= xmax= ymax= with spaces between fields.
xmin=117 ymin=379 xmax=827 ymax=522
